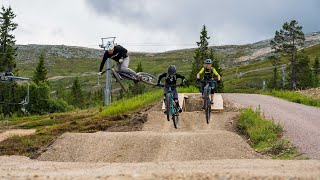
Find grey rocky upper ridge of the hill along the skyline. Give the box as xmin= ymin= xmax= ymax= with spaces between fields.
xmin=17 ymin=32 xmax=320 ymax=66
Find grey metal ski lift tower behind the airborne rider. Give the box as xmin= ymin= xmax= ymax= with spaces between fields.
xmin=99 ymin=37 xmax=116 ymax=106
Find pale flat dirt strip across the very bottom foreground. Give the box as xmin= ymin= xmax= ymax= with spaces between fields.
xmin=0 ymin=157 xmax=320 ymax=180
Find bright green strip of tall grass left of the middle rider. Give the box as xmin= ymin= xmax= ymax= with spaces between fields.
xmin=101 ymin=89 xmax=163 ymax=116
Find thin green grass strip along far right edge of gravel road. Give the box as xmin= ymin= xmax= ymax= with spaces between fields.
xmin=262 ymin=91 xmax=320 ymax=107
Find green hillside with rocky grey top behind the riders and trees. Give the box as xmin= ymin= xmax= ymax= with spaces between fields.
xmin=12 ymin=32 xmax=320 ymax=92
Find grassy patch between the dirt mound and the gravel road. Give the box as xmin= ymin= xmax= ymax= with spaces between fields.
xmin=237 ymin=108 xmax=297 ymax=159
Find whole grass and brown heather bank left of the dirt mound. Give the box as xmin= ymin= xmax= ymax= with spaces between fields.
xmin=0 ymin=89 xmax=168 ymax=158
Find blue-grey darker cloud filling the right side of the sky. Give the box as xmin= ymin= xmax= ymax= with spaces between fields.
xmin=86 ymin=0 xmax=320 ymax=44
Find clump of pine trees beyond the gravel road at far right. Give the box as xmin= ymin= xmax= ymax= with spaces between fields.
xmin=269 ymin=20 xmax=319 ymax=90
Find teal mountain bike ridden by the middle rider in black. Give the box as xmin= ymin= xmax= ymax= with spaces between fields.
xmin=160 ymin=85 xmax=182 ymax=129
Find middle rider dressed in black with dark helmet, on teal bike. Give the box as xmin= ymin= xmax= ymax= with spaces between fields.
xmin=157 ymin=65 xmax=185 ymax=113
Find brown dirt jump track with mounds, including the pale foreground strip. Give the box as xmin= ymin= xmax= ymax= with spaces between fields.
xmin=0 ymin=95 xmax=320 ymax=179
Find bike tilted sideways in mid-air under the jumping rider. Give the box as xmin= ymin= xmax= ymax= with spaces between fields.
xmin=102 ymin=66 xmax=158 ymax=91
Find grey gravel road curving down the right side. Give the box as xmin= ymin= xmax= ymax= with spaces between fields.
xmin=222 ymin=94 xmax=320 ymax=160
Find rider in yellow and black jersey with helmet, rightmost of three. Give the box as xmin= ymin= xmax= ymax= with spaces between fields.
xmin=197 ymin=59 xmax=221 ymax=109
